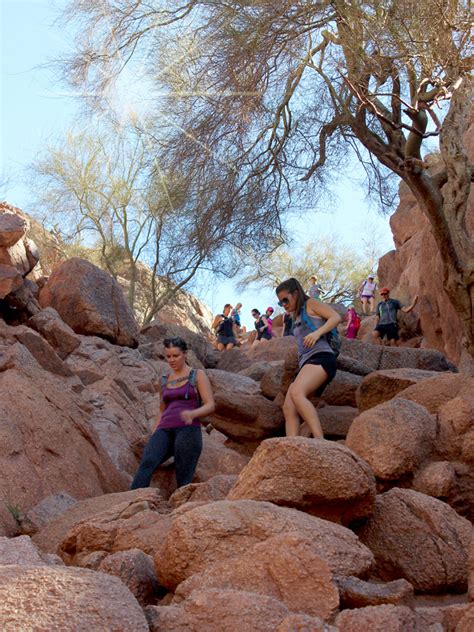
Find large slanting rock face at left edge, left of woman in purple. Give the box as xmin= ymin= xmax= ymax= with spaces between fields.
xmin=0 ymin=344 xmax=127 ymax=536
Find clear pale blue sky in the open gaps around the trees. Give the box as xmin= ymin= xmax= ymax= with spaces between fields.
xmin=0 ymin=0 xmax=393 ymax=326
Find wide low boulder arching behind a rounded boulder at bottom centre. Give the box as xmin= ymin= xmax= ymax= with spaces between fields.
xmin=155 ymin=500 xmax=372 ymax=590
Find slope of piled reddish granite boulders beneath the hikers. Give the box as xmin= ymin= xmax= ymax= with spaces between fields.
xmin=0 ymin=237 xmax=474 ymax=632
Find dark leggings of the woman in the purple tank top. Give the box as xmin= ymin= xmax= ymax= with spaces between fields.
xmin=130 ymin=426 xmax=202 ymax=489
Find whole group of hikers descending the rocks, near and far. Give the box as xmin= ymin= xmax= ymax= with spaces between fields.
xmin=131 ymin=275 xmax=418 ymax=489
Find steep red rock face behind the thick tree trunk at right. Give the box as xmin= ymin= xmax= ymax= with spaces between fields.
xmin=378 ymin=113 xmax=474 ymax=363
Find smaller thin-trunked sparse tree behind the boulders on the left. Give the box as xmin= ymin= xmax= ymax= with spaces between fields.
xmin=31 ymin=124 xmax=282 ymax=323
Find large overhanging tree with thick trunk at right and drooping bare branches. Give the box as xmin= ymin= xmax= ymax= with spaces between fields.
xmin=59 ymin=0 xmax=474 ymax=356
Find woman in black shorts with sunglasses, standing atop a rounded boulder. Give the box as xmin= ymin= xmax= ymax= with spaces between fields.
xmin=276 ymin=278 xmax=341 ymax=439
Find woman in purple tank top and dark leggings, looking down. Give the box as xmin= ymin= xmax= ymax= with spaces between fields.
xmin=130 ymin=338 xmax=215 ymax=489
